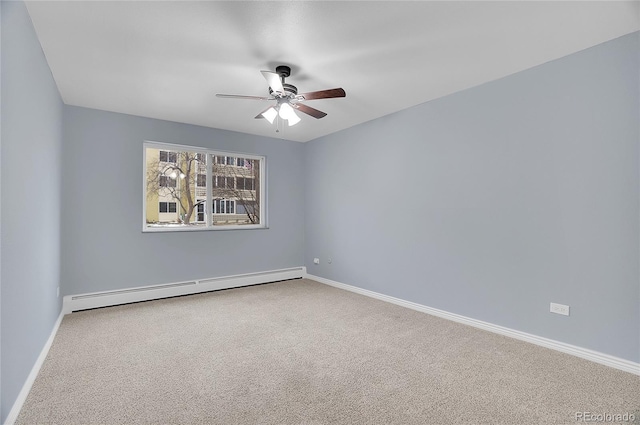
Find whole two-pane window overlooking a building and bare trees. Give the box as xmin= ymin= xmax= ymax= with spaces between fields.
xmin=143 ymin=142 xmax=266 ymax=231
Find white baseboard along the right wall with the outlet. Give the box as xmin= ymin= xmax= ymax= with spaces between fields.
xmin=305 ymin=274 xmax=640 ymax=375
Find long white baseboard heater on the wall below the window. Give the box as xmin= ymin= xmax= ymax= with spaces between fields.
xmin=62 ymin=267 xmax=306 ymax=314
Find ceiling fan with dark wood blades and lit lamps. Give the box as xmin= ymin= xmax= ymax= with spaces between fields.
xmin=216 ymin=65 xmax=346 ymax=126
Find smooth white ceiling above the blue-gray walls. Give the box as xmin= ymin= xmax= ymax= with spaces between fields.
xmin=27 ymin=1 xmax=640 ymax=142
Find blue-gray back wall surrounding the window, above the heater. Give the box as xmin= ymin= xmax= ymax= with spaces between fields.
xmin=61 ymin=106 xmax=304 ymax=295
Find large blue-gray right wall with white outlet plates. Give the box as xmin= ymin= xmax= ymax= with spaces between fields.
xmin=305 ymin=33 xmax=640 ymax=362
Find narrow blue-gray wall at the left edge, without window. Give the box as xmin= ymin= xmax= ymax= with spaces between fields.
xmin=0 ymin=1 xmax=63 ymax=422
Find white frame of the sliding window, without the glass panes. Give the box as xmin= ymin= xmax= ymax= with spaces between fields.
xmin=142 ymin=141 xmax=269 ymax=233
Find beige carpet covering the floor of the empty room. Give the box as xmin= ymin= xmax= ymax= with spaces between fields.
xmin=17 ymin=280 xmax=640 ymax=425
